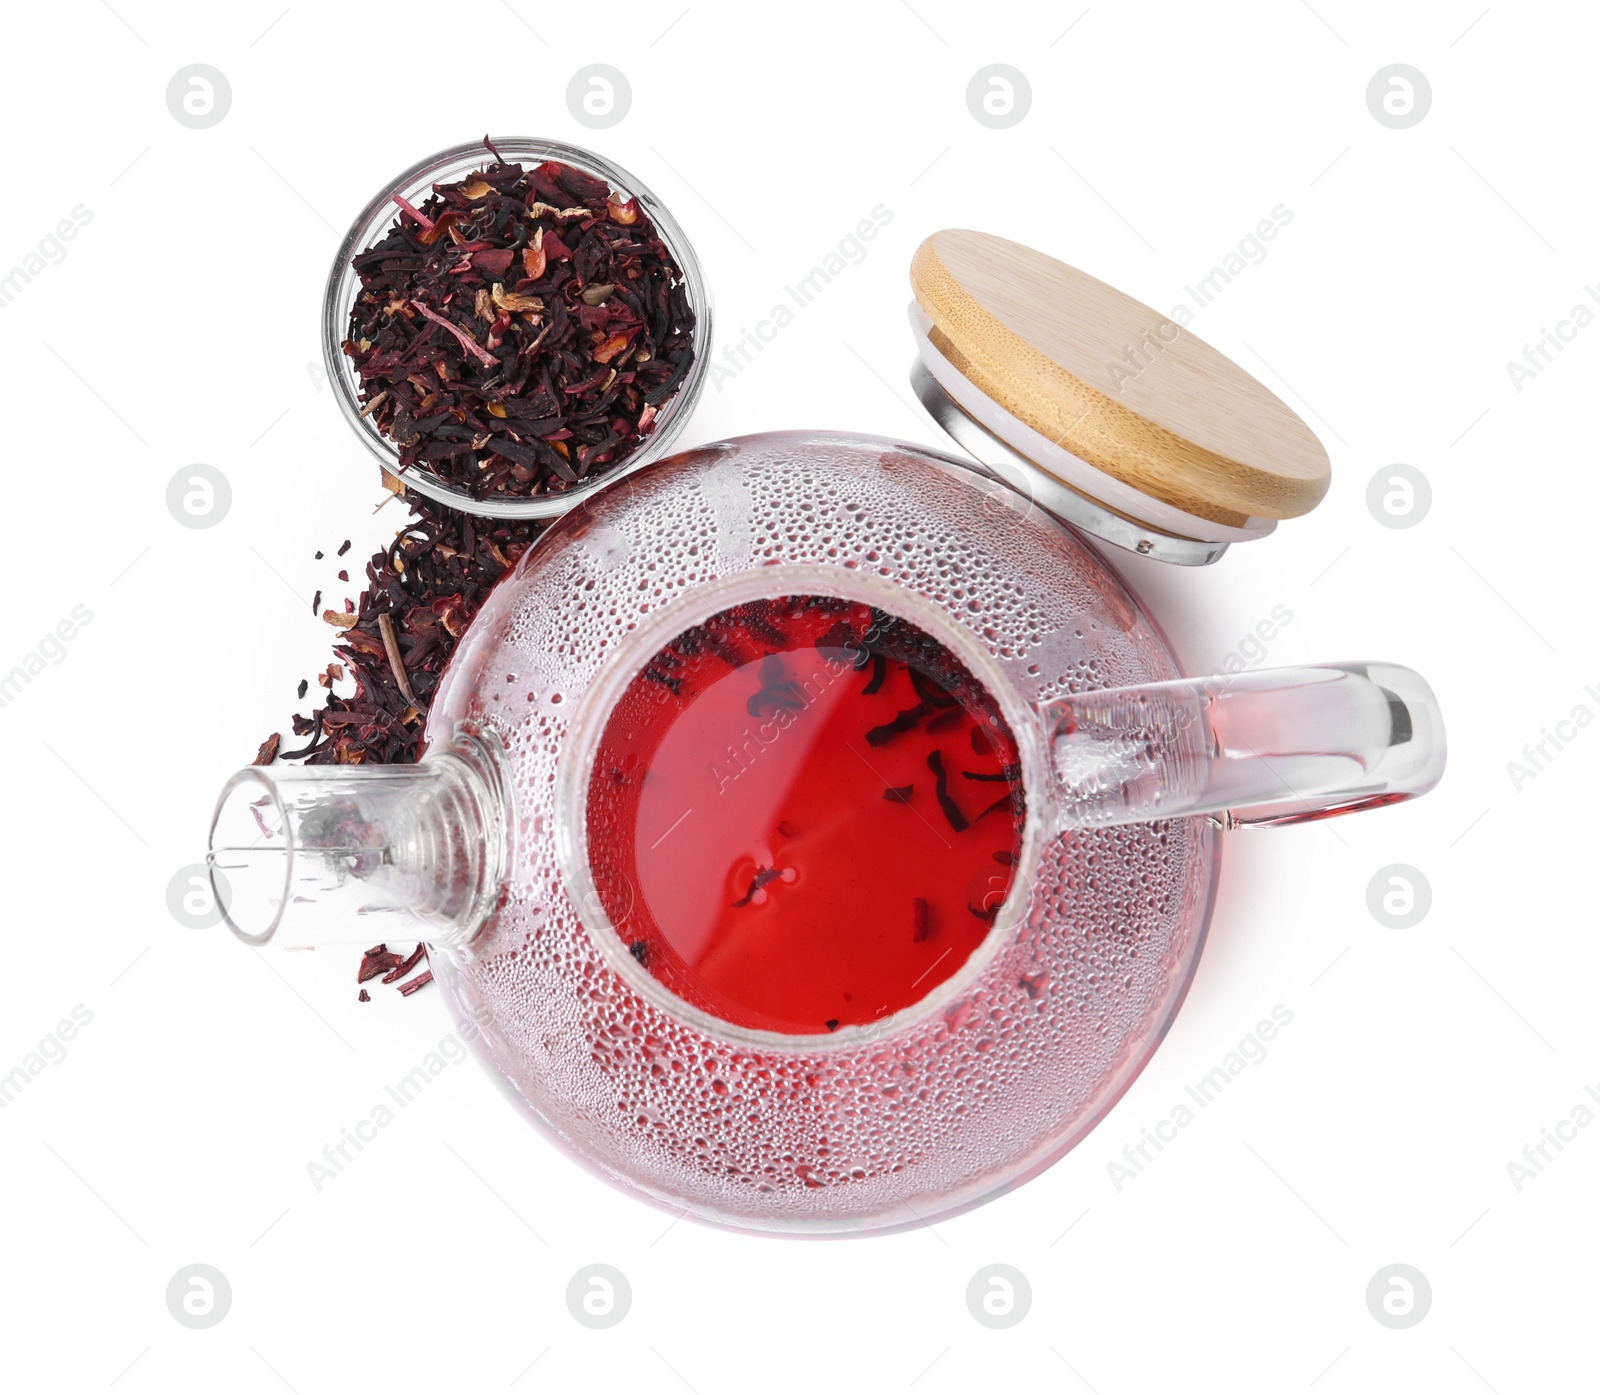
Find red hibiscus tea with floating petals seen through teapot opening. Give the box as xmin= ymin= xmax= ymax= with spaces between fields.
xmin=587 ymin=595 xmax=1026 ymax=1035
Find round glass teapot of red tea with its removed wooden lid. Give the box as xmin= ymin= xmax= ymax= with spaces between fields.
xmin=211 ymin=217 xmax=1445 ymax=1233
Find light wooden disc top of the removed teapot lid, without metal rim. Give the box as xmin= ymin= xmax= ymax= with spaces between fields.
xmin=910 ymin=229 xmax=1330 ymax=526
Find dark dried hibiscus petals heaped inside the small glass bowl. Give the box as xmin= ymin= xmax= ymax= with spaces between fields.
xmin=344 ymin=138 xmax=694 ymax=499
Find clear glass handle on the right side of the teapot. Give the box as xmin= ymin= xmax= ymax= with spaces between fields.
xmin=1040 ymin=664 xmax=1445 ymax=832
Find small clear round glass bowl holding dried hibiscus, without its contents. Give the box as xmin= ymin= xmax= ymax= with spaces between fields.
xmin=322 ymin=136 xmax=712 ymax=518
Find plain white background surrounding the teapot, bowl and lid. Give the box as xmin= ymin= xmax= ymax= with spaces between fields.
xmin=0 ymin=0 xmax=1600 ymax=1395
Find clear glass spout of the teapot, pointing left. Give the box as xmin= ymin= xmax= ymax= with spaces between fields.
xmin=206 ymin=731 xmax=510 ymax=949
